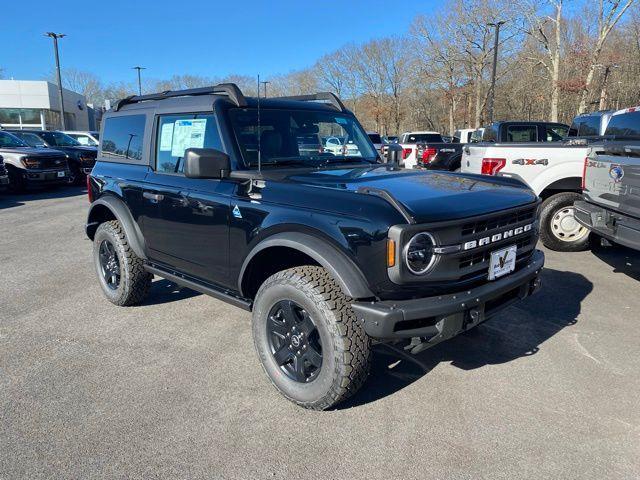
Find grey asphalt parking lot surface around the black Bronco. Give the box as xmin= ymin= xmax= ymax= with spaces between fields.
xmin=0 ymin=188 xmax=640 ymax=480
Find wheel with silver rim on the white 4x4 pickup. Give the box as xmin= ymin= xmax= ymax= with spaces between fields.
xmin=540 ymin=192 xmax=589 ymax=252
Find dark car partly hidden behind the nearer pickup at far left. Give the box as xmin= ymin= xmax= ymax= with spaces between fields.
xmin=7 ymin=130 xmax=98 ymax=185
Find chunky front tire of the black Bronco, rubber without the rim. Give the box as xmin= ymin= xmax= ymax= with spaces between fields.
xmin=253 ymin=266 xmax=371 ymax=410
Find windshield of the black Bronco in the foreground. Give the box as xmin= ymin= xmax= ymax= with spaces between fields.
xmin=229 ymin=108 xmax=378 ymax=167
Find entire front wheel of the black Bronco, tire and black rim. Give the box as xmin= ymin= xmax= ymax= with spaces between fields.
xmin=253 ymin=266 xmax=371 ymax=410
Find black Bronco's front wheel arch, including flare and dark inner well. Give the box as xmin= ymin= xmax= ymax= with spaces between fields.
xmin=238 ymin=232 xmax=374 ymax=299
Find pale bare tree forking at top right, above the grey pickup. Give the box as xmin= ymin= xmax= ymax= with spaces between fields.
xmin=578 ymin=0 xmax=635 ymax=113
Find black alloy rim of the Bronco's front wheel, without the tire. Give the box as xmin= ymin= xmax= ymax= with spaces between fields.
xmin=267 ymin=300 xmax=322 ymax=383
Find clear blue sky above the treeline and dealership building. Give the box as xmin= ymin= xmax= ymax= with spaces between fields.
xmin=0 ymin=0 xmax=442 ymax=82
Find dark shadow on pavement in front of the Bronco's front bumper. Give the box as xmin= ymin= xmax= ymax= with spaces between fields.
xmin=338 ymin=268 xmax=593 ymax=409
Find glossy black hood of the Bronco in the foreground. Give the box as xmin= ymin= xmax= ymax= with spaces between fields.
xmin=272 ymin=165 xmax=537 ymax=223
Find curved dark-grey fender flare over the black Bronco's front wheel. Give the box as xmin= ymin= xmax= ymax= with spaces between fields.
xmin=238 ymin=232 xmax=375 ymax=299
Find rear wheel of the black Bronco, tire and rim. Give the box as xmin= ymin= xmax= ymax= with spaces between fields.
xmin=93 ymin=220 xmax=153 ymax=306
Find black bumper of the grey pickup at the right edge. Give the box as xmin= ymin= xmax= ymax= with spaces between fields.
xmin=573 ymin=200 xmax=640 ymax=250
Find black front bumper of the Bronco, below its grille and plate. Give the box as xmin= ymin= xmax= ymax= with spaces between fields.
xmin=351 ymin=250 xmax=544 ymax=345
